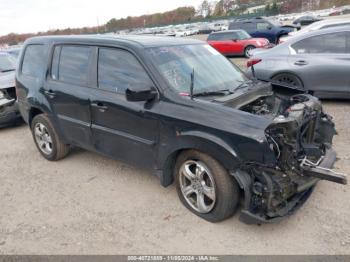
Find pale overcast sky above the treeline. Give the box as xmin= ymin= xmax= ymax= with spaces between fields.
xmin=0 ymin=0 xmax=202 ymax=35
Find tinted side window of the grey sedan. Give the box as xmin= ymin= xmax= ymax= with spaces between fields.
xmin=292 ymin=32 xmax=347 ymax=54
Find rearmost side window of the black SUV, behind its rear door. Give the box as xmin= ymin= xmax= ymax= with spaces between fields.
xmin=22 ymin=45 xmax=44 ymax=78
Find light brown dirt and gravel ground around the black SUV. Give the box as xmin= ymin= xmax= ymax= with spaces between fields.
xmin=0 ymin=54 xmax=350 ymax=254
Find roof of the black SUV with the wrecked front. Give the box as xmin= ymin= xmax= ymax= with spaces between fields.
xmin=27 ymin=35 xmax=203 ymax=47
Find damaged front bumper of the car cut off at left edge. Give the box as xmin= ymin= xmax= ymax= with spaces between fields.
xmin=0 ymin=98 xmax=21 ymax=127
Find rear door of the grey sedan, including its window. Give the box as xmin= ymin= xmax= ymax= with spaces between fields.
xmin=289 ymin=32 xmax=350 ymax=94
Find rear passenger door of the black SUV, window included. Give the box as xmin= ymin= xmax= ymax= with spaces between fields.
xmin=42 ymin=45 xmax=93 ymax=148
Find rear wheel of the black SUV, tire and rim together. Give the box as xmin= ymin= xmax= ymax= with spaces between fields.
xmin=31 ymin=114 xmax=70 ymax=161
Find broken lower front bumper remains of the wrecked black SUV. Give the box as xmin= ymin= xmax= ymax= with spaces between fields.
xmin=240 ymin=149 xmax=344 ymax=224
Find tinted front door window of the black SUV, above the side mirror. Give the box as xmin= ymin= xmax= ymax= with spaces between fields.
xmin=98 ymin=48 xmax=153 ymax=93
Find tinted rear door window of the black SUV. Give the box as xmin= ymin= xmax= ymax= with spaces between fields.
xmin=56 ymin=46 xmax=91 ymax=85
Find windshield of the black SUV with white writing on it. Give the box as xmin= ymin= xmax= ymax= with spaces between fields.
xmin=147 ymin=44 xmax=248 ymax=94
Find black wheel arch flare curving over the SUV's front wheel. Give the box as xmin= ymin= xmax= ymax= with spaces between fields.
xmin=156 ymin=131 xmax=241 ymax=187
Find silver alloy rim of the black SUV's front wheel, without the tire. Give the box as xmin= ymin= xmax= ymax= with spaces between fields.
xmin=179 ymin=160 xmax=216 ymax=214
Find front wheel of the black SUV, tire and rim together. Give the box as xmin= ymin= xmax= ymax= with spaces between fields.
xmin=175 ymin=150 xmax=239 ymax=223
